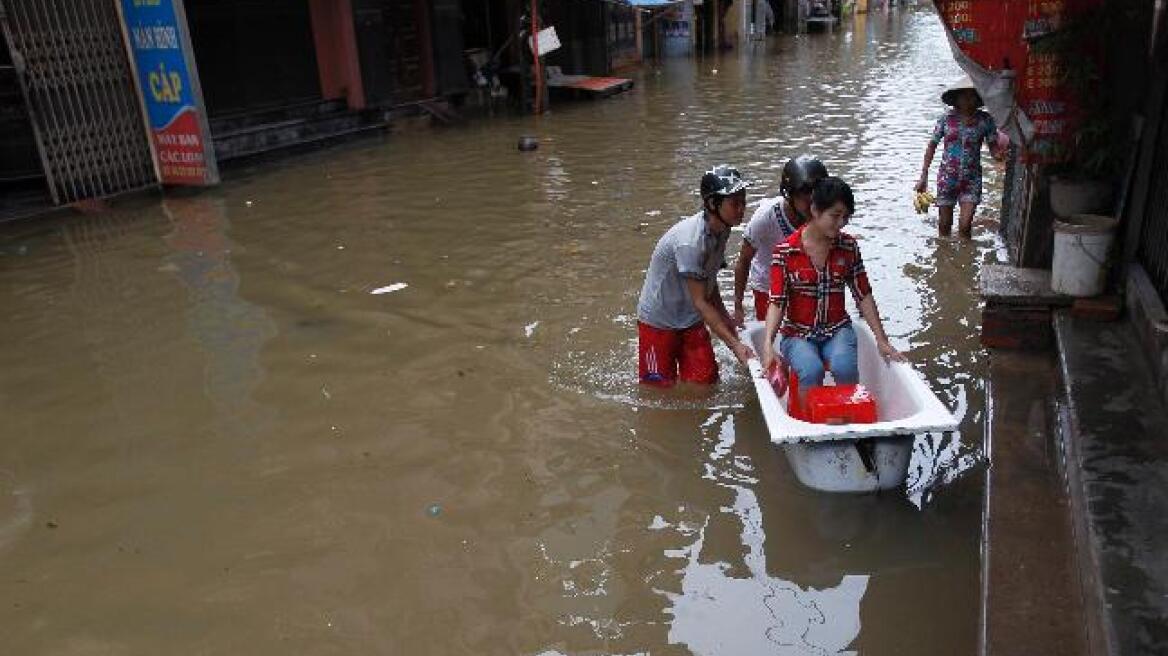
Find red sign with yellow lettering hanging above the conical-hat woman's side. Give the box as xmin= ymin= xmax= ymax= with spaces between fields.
xmin=937 ymin=0 xmax=1101 ymax=163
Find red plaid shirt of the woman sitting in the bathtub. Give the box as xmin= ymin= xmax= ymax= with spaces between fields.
xmin=771 ymin=228 xmax=872 ymax=339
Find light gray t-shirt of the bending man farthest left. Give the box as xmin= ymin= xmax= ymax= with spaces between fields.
xmin=637 ymin=212 xmax=730 ymax=330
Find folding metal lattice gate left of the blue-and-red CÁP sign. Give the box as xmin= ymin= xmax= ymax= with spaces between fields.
xmin=0 ymin=0 xmax=158 ymax=204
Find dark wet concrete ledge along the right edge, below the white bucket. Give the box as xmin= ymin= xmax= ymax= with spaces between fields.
xmin=1055 ymin=310 xmax=1168 ymax=656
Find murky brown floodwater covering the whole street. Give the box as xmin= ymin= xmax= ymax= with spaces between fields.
xmin=0 ymin=9 xmax=1000 ymax=656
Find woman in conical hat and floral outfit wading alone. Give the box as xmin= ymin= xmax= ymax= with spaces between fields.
xmin=916 ymin=76 xmax=997 ymax=237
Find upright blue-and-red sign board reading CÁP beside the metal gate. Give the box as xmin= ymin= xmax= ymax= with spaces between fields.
xmin=118 ymin=0 xmax=218 ymax=186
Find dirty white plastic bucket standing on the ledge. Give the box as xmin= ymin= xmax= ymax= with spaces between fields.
xmin=1050 ymin=214 xmax=1119 ymax=296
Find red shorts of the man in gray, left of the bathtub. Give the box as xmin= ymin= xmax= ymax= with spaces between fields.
xmin=637 ymin=321 xmax=718 ymax=388
